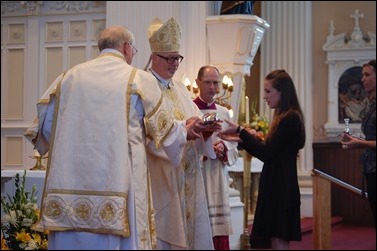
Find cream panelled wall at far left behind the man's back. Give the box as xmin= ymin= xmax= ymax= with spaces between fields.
xmin=1 ymin=1 xmax=106 ymax=169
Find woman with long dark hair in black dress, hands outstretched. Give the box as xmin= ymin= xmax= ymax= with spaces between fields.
xmin=219 ymin=70 xmax=305 ymax=250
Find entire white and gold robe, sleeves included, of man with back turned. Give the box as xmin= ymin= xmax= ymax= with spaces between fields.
xmin=25 ymin=53 xmax=173 ymax=249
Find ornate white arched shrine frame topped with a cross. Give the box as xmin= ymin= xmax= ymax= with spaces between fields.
xmin=323 ymin=10 xmax=376 ymax=140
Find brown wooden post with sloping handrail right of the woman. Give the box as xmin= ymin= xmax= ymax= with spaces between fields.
xmin=312 ymin=169 xmax=368 ymax=250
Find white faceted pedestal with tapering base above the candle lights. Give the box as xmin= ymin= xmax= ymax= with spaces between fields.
xmin=206 ymin=14 xmax=270 ymax=121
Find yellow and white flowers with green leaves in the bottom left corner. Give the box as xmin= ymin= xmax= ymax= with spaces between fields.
xmin=1 ymin=170 xmax=48 ymax=250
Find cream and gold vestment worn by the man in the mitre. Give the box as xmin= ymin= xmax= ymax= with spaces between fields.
xmin=147 ymin=80 xmax=213 ymax=250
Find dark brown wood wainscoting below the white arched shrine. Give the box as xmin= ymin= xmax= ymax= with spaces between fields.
xmin=313 ymin=140 xmax=374 ymax=226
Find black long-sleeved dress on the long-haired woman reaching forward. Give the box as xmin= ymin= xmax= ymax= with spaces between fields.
xmin=240 ymin=112 xmax=304 ymax=247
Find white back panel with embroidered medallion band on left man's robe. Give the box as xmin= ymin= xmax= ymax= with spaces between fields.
xmin=32 ymin=56 xmax=132 ymax=237
